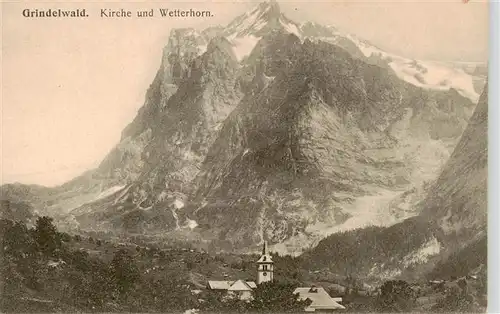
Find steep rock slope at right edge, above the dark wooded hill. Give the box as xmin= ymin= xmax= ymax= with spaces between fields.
xmin=422 ymin=84 xmax=488 ymax=244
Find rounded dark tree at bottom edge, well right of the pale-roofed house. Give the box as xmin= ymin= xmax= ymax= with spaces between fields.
xmin=377 ymin=280 xmax=416 ymax=312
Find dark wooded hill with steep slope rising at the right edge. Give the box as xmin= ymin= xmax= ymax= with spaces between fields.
xmin=303 ymin=84 xmax=488 ymax=279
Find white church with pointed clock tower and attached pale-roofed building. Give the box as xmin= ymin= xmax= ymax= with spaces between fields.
xmin=207 ymin=242 xmax=274 ymax=300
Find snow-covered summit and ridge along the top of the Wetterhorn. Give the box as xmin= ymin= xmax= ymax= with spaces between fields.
xmin=164 ymin=0 xmax=484 ymax=103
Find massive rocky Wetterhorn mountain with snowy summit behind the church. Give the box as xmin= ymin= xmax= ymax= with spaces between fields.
xmin=2 ymin=2 xmax=484 ymax=253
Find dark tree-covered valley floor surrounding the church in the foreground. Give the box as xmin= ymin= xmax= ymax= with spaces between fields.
xmin=0 ymin=217 xmax=486 ymax=313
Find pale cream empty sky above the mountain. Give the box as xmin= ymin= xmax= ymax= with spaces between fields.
xmin=0 ymin=0 xmax=488 ymax=186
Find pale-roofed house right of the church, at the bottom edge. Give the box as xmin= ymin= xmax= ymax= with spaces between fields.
xmin=293 ymin=286 xmax=345 ymax=312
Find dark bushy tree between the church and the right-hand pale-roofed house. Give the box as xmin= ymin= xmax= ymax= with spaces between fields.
xmin=249 ymin=282 xmax=311 ymax=312
